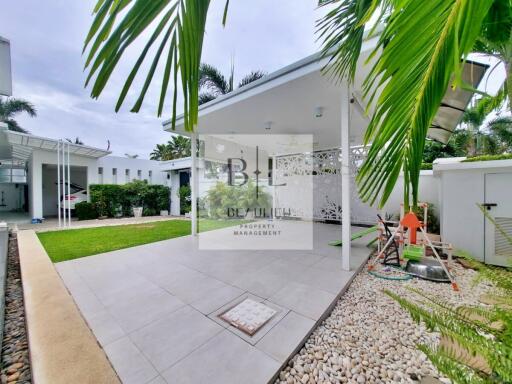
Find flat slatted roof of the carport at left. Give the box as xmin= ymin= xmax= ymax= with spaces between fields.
xmin=0 ymin=130 xmax=110 ymax=161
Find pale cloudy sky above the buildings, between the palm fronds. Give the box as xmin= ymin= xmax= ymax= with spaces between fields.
xmin=0 ymin=0 xmax=320 ymax=158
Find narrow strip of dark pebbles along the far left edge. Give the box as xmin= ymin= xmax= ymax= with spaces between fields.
xmin=0 ymin=234 xmax=31 ymax=384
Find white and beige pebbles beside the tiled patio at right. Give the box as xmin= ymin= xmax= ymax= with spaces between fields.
xmin=276 ymin=263 xmax=489 ymax=384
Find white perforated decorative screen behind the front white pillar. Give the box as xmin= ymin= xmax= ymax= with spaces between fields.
xmin=274 ymin=146 xmax=377 ymax=224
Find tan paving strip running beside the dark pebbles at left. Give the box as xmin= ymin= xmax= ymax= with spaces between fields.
xmin=18 ymin=230 xmax=120 ymax=384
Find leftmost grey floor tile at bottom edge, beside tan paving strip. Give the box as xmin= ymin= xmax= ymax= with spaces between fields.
xmin=105 ymin=337 xmax=158 ymax=384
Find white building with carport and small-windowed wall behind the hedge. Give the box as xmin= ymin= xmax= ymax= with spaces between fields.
xmin=0 ymin=126 xmax=175 ymax=221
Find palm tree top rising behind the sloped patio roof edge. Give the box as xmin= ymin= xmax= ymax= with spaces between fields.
xmin=199 ymin=63 xmax=265 ymax=105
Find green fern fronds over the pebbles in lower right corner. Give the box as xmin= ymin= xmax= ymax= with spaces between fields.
xmin=385 ymin=205 xmax=512 ymax=384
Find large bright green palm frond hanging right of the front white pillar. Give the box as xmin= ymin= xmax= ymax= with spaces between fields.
xmin=357 ymin=0 xmax=492 ymax=206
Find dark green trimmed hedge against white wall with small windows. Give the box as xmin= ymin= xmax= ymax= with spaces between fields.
xmin=89 ymin=180 xmax=170 ymax=217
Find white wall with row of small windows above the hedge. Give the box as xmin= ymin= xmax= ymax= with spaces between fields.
xmin=94 ymin=156 xmax=167 ymax=185
